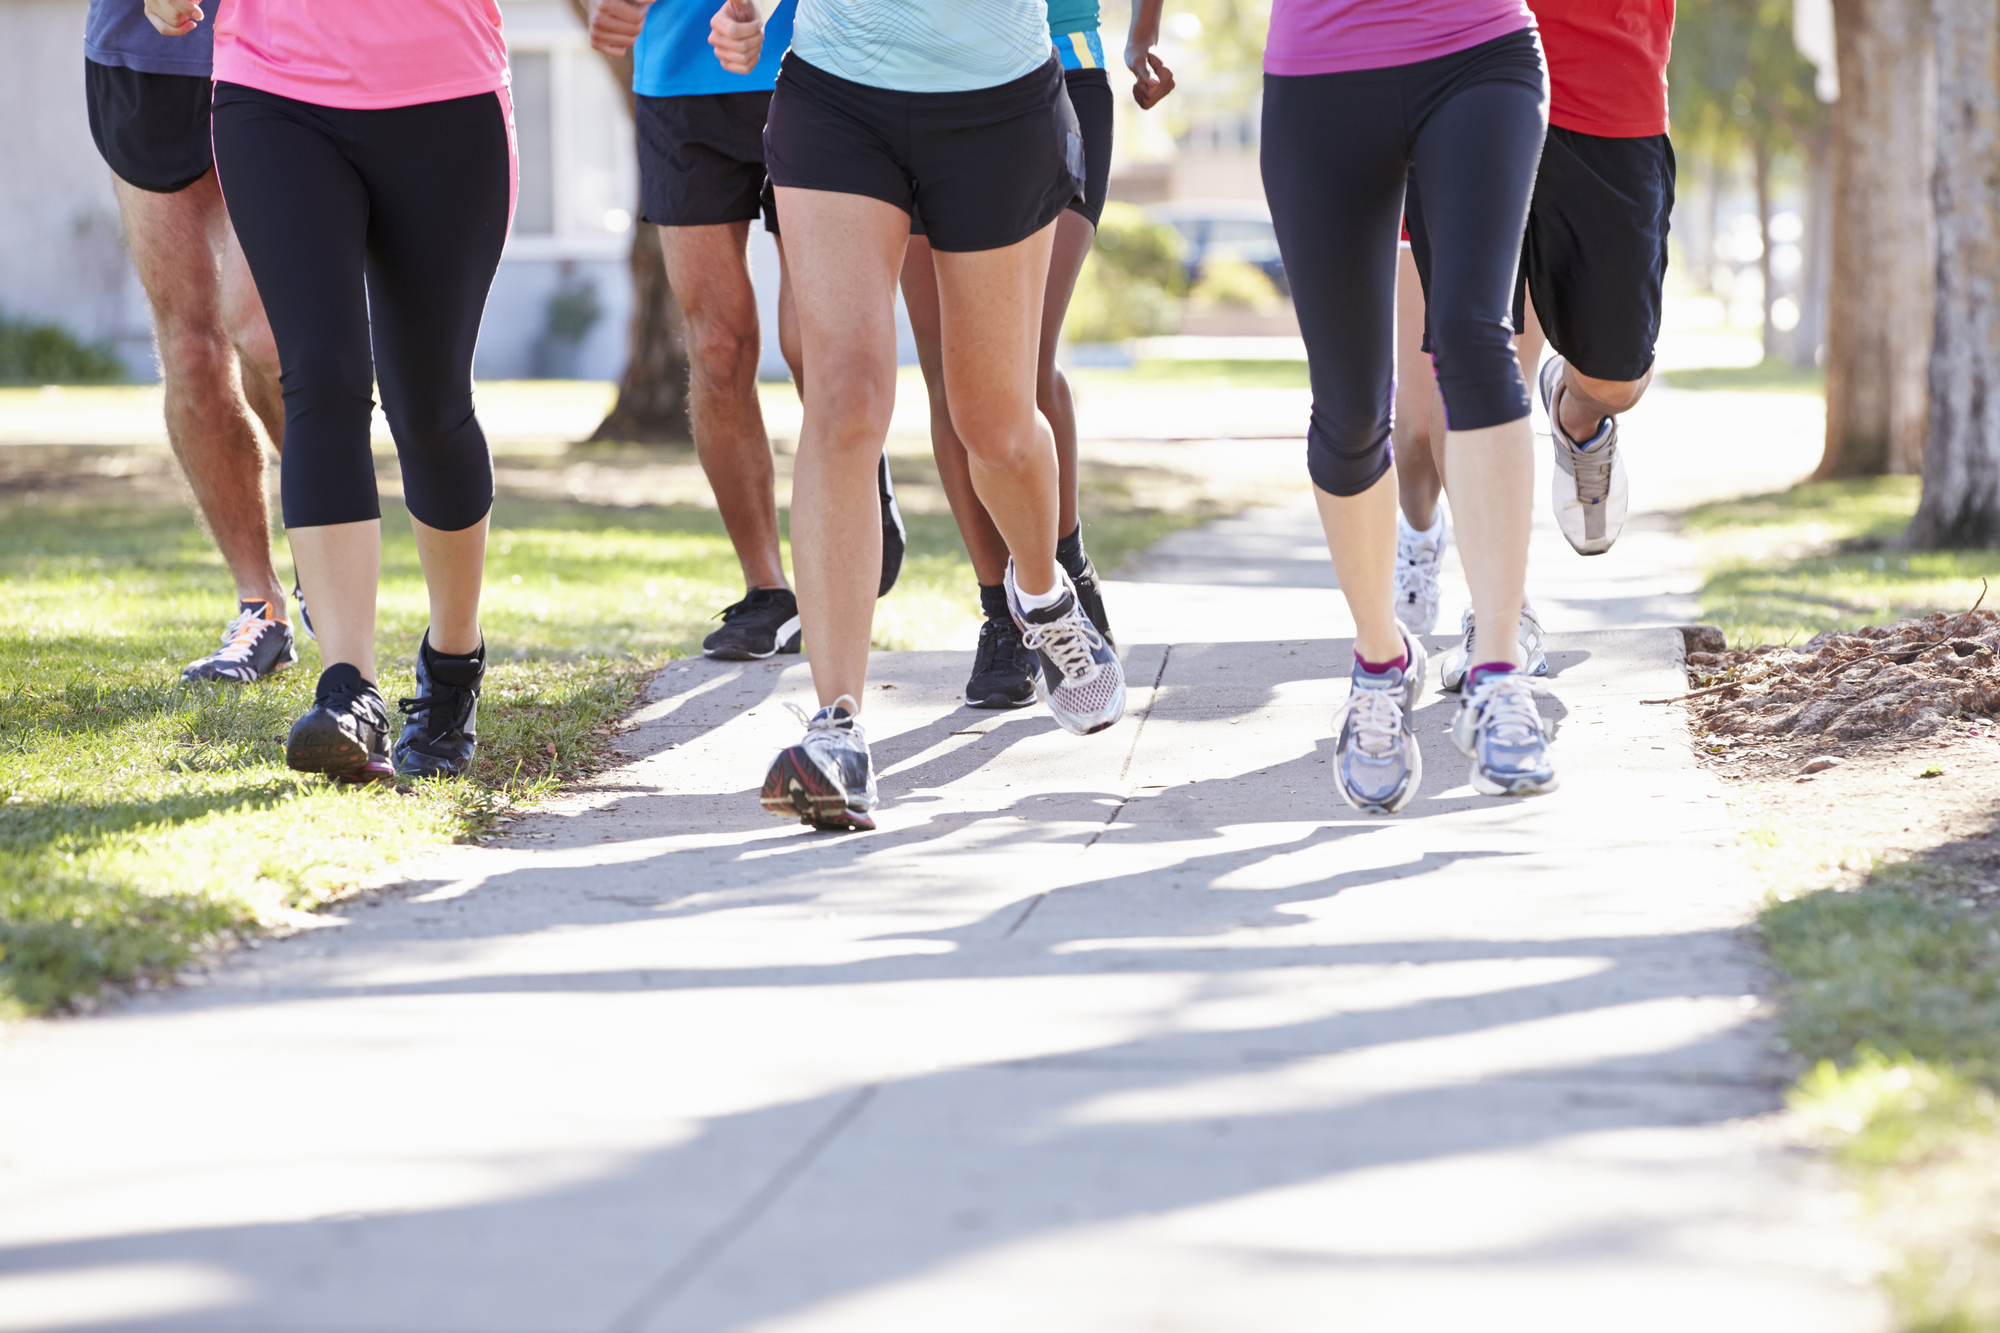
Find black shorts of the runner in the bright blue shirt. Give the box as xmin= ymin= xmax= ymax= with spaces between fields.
xmin=636 ymin=92 xmax=778 ymax=230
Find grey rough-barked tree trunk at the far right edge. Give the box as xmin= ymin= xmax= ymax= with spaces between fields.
xmin=1904 ymin=0 xmax=2000 ymax=548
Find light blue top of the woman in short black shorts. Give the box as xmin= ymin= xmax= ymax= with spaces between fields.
xmin=792 ymin=0 xmax=1050 ymax=92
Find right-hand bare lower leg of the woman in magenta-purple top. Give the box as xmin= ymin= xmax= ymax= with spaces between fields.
xmin=1440 ymin=416 xmax=1534 ymax=667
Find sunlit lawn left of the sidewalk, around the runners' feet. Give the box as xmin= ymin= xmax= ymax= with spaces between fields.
xmin=0 ymin=450 xmax=1198 ymax=1015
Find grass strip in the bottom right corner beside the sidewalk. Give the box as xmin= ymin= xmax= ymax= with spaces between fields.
xmin=1762 ymin=863 xmax=2000 ymax=1333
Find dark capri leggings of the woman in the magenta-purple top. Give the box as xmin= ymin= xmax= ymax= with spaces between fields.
xmin=1264 ymin=30 xmax=1548 ymax=494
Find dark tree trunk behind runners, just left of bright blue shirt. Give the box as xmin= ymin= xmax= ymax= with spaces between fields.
xmin=570 ymin=0 xmax=694 ymax=444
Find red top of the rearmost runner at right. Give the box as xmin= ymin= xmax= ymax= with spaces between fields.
xmin=1528 ymin=0 xmax=1674 ymax=138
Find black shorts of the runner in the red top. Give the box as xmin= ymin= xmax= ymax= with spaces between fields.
xmin=1406 ymin=126 xmax=1676 ymax=382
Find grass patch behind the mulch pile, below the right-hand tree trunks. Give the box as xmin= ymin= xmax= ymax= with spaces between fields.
xmin=1686 ymin=476 xmax=2000 ymax=644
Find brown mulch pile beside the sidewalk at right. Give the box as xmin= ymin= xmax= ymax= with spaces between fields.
xmin=1688 ymin=606 xmax=2000 ymax=741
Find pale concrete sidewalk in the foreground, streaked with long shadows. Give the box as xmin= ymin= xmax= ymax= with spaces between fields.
xmin=0 ymin=630 xmax=1888 ymax=1333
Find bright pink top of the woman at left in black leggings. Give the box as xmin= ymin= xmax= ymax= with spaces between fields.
xmin=214 ymin=0 xmax=508 ymax=110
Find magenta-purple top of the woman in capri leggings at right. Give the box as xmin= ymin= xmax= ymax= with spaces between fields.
xmin=1264 ymin=0 xmax=1534 ymax=74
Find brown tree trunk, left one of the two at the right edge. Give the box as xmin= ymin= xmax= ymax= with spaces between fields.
xmin=1814 ymin=0 xmax=1936 ymax=478
